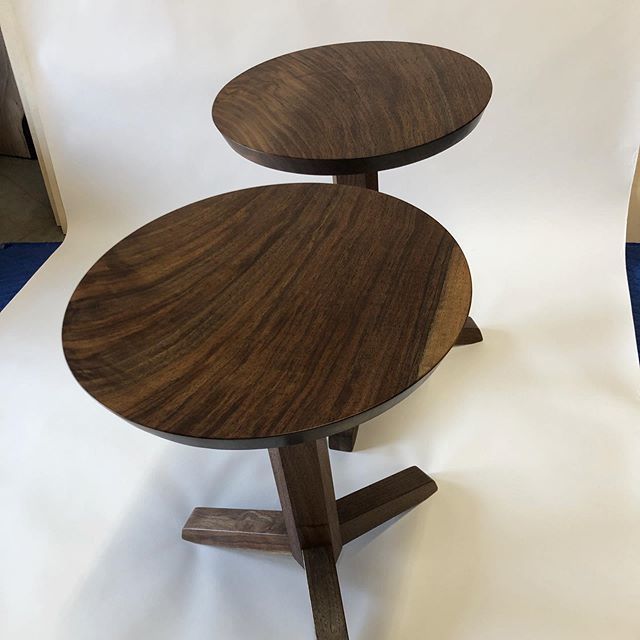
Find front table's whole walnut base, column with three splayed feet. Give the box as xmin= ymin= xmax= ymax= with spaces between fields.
xmin=182 ymin=438 xmax=437 ymax=640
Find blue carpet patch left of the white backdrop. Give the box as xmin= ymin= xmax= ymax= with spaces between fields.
xmin=0 ymin=242 xmax=61 ymax=310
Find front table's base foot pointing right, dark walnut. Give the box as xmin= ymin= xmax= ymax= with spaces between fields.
xmin=338 ymin=467 xmax=438 ymax=544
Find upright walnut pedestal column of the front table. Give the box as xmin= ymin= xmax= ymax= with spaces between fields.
xmin=269 ymin=438 xmax=342 ymax=564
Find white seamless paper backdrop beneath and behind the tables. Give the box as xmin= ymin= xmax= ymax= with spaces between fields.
xmin=0 ymin=0 xmax=640 ymax=640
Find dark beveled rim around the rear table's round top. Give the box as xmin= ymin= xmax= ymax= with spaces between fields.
xmin=211 ymin=40 xmax=493 ymax=175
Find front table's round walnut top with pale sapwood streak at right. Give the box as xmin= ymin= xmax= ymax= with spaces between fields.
xmin=62 ymin=184 xmax=471 ymax=449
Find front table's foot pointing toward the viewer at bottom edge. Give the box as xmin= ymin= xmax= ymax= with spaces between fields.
xmin=303 ymin=546 xmax=349 ymax=640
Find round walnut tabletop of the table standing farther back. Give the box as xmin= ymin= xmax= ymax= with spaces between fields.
xmin=213 ymin=42 xmax=492 ymax=175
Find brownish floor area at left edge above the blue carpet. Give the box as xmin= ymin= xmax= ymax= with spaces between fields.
xmin=0 ymin=156 xmax=64 ymax=244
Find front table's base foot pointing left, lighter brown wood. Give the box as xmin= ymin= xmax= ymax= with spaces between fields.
xmin=182 ymin=507 xmax=291 ymax=553
